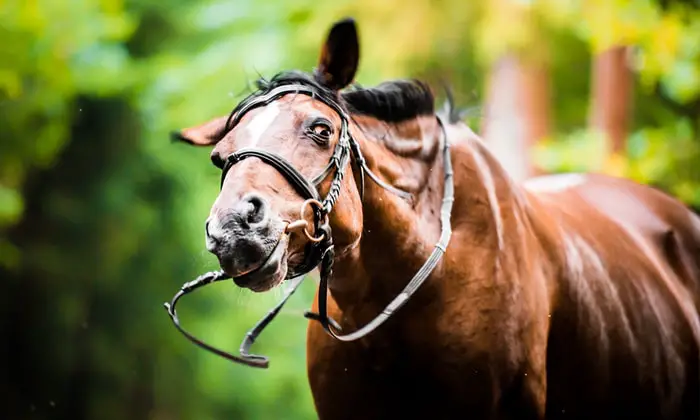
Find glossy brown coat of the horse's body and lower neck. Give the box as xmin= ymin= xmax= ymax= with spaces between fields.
xmin=307 ymin=119 xmax=700 ymax=419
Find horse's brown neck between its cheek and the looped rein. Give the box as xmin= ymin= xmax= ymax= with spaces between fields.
xmin=330 ymin=112 xmax=444 ymax=314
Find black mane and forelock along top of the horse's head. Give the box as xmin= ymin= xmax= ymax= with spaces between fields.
xmin=243 ymin=71 xmax=435 ymax=122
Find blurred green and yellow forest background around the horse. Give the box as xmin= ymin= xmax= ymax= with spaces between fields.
xmin=0 ymin=0 xmax=700 ymax=420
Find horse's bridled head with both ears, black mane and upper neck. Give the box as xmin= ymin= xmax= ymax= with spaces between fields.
xmin=177 ymin=19 xmax=448 ymax=292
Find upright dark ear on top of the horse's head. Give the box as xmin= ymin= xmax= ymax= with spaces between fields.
xmin=314 ymin=18 xmax=360 ymax=90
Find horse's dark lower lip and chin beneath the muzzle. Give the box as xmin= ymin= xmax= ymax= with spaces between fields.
xmin=233 ymin=235 xmax=288 ymax=293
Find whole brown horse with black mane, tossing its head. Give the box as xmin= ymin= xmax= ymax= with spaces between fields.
xmin=172 ymin=20 xmax=700 ymax=420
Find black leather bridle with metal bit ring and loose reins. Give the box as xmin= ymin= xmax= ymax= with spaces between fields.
xmin=164 ymin=84 xmax=454 ymax=368
